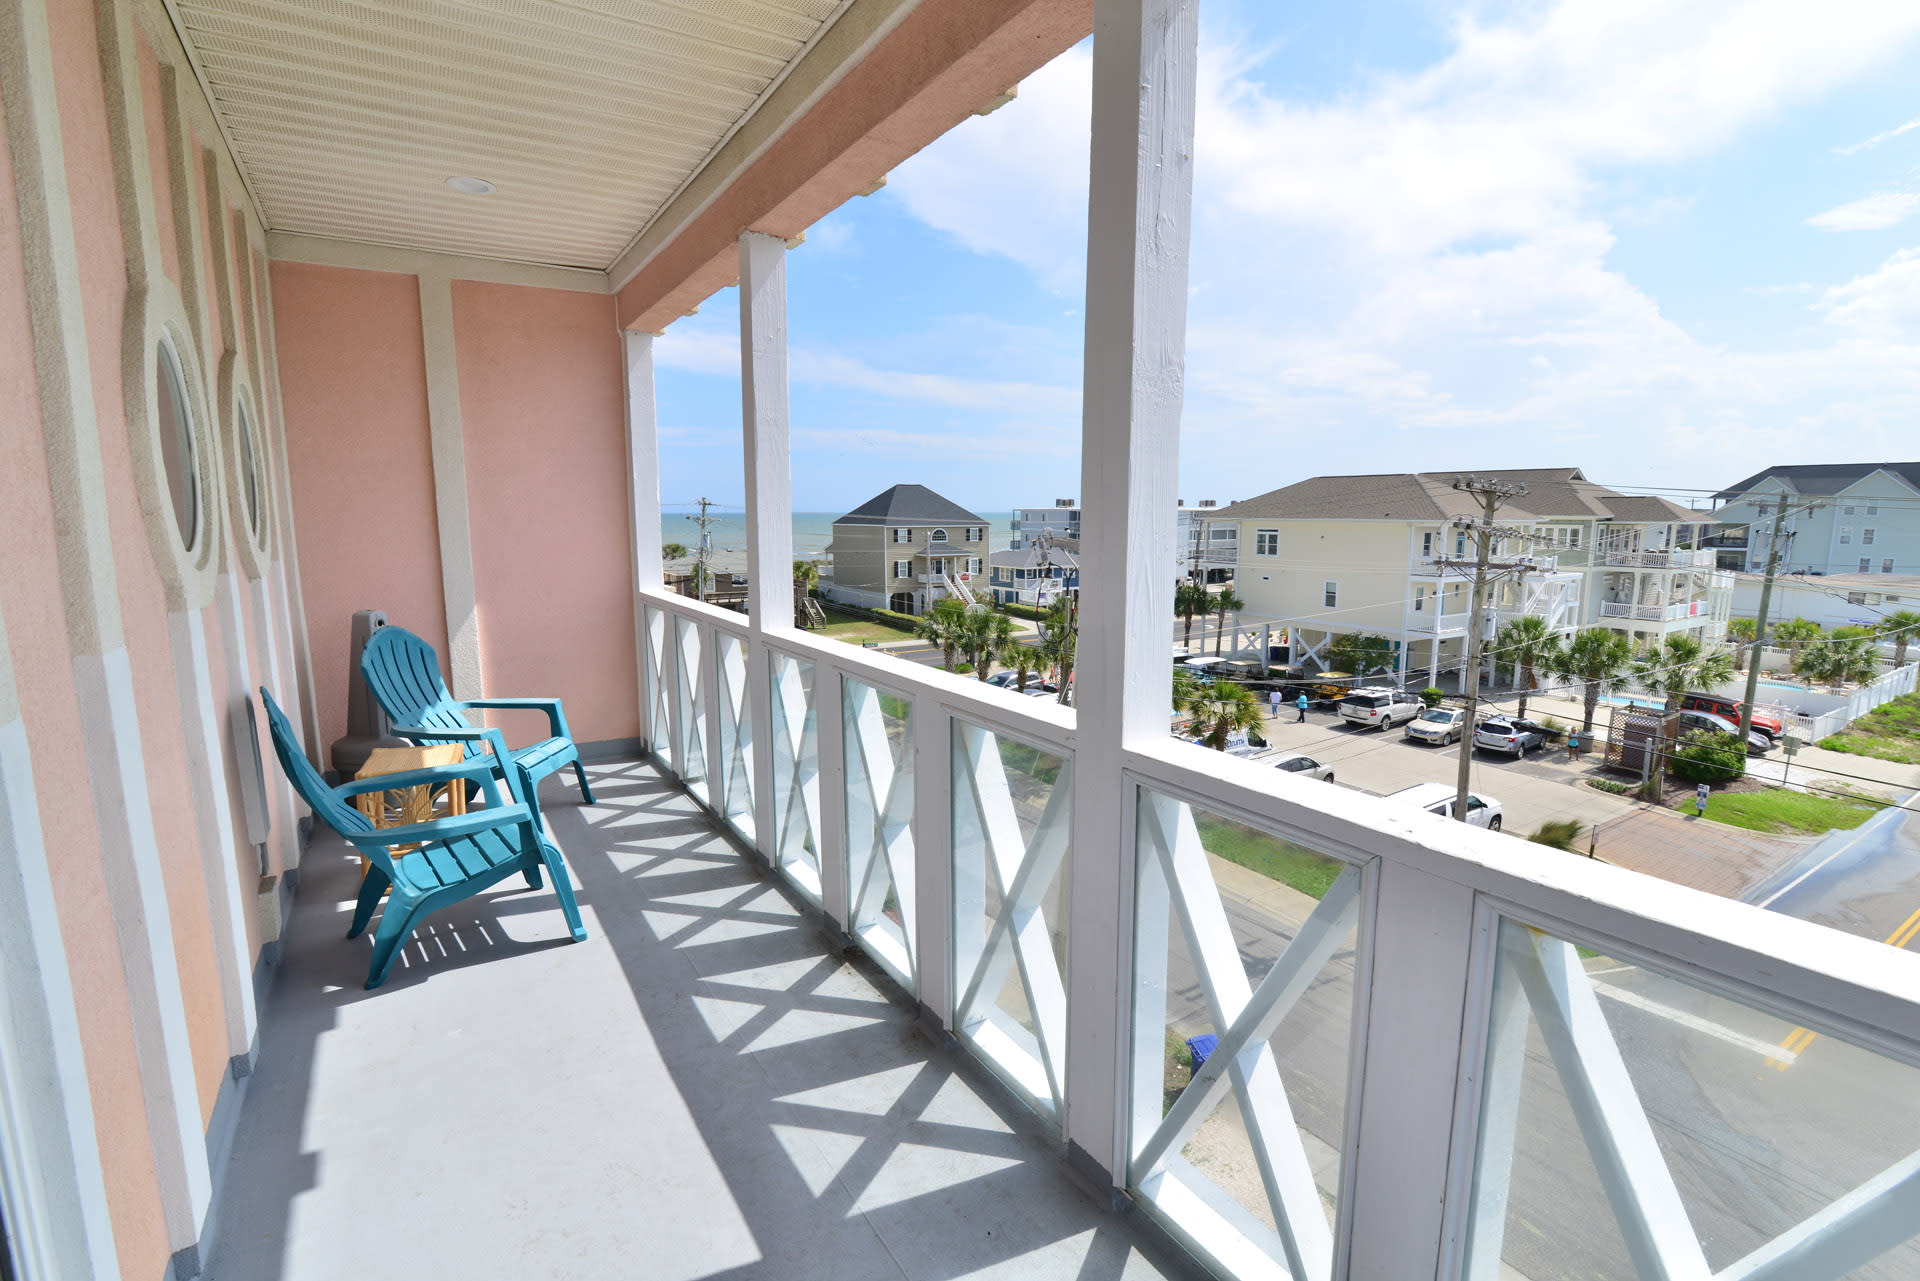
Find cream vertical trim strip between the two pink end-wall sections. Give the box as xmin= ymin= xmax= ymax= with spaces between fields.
xmin=420 ymin=273 xmax=480 ymax=699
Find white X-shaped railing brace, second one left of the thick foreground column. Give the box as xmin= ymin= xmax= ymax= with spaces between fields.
xmin=841 ymin=680 xmax=920 ymax=991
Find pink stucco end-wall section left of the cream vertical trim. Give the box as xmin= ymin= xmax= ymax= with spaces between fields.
xmin=273 ymin=263 xmax=447 ymax=751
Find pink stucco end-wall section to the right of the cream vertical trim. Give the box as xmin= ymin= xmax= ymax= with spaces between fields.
xmin=453 ymin=280 xmax=639 ymax=741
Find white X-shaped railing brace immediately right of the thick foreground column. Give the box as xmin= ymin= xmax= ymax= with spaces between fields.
xmin=1129 ymin=789 xmax=1361 ymax=1281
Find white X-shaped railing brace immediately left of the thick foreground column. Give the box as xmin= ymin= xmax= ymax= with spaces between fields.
xmin=952 ymin=720 xmax=1073 ymax=1114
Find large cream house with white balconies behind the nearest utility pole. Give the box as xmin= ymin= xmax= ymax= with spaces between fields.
xmin=1208 ymin=469 xmax=1732 ymax=676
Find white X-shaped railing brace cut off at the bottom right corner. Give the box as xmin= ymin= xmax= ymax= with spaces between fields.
xmin=1463 ymin=922 xmax=1920 ymax=1281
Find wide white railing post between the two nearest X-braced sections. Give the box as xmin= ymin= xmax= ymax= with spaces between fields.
xmin=1332 ymin=860 xmax=1492 ymax=1277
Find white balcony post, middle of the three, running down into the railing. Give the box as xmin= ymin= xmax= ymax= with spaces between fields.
xmin=739 ymin=230 xmax=791 ymax=860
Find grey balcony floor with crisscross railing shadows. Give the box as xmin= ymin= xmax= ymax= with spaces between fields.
xmin=207 ymin=762 xmax=1190 ymax=1281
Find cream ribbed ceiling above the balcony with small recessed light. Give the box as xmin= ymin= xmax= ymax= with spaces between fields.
xmin=169 ymin=0 xmax=845 ymax=269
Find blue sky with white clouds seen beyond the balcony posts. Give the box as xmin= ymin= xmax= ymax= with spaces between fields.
xmin=659 ymin=0 xmax=1920 ymax=511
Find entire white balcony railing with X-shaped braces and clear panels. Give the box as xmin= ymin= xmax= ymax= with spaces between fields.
xmin=639 ymin=592 xmax=1920 ymax=1281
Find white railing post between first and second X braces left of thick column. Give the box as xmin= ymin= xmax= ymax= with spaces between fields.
xmin=910 ymin=691 xmax=948 ymax=1031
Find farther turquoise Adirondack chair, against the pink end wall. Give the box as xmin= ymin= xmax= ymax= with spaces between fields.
xmin=361 ymin=628 xmax=593 ymax=812
